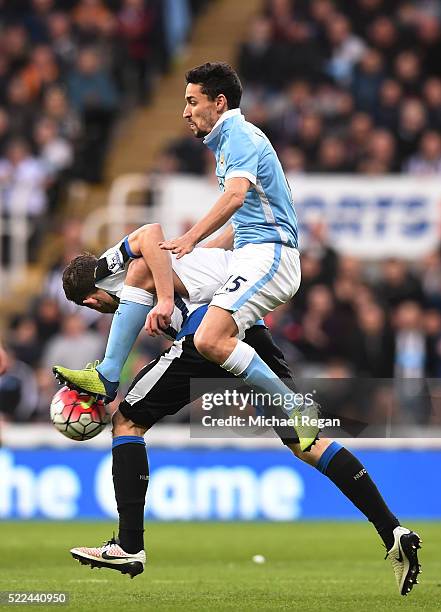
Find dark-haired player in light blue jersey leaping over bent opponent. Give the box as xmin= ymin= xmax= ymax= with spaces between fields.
xmin=158 ymin=63 xmax=318 ymax=450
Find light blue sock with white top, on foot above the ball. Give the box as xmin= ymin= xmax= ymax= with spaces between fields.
xmin=97 ymin=287 xmax=153 ymax=382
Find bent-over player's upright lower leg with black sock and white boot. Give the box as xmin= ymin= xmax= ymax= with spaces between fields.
xmin=70 ymin=411 xmax=149 ymax=578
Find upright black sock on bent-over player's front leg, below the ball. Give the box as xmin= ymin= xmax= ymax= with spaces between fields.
xmin=112 ymin=436 xmax=149 ymax=553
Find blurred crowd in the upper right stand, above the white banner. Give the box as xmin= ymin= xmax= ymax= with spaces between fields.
xmin=163 ymin=0 xmax=441 ymax=176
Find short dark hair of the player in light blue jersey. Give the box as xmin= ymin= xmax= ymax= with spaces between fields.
xmin=185 ymin=62 xmax=242 ymax=109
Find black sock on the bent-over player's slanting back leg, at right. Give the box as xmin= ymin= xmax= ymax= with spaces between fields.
xmin=317 ymin=446 xmax=400 ymax=550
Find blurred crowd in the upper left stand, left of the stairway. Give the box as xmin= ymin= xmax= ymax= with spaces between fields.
xmin=0 ymin=0 xmax=208 ymax=265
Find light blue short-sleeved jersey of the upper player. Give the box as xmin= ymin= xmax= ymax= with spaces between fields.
xmin=204 ymin=108 xmax=298 ymax=248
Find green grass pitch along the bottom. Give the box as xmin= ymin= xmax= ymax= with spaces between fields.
xmin=0 ymin=522 xmax=441 ymax=612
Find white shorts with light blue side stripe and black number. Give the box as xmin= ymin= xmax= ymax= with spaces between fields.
xmin=211 ymin=243 xmax=301 ymax=337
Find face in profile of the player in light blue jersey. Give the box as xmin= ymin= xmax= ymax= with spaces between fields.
xmin=183 ymin=83 xmax=226 ymax=138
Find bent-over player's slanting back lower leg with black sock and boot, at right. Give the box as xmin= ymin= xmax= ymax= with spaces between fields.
xmin=288 ymin=438 xmax=421 ymax=595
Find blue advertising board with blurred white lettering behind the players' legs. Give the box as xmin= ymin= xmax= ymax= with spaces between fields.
xmin=0 ymin=448 xmax=441 ymax=521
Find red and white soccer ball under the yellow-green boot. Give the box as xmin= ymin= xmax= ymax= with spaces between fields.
xmin=50 ymin=387 xmax=110 ymax=441
